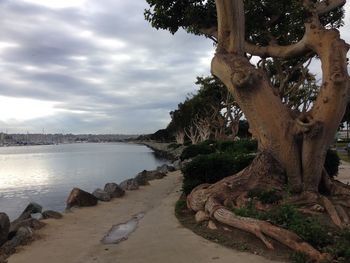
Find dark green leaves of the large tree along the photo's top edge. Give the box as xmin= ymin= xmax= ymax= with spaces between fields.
xmin=145 ymin=0 xmax=344 ymax=46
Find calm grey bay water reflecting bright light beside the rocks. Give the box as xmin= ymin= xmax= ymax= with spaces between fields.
xmin=0 ymin=143 xmax=166 ymax=219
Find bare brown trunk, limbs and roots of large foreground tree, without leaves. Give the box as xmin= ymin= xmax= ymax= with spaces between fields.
xmin=188 ymin=0 xmax=350 ymax=260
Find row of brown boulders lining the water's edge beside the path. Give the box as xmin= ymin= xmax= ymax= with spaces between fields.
xmin=0 ymin=148 xmax=175 ymax=263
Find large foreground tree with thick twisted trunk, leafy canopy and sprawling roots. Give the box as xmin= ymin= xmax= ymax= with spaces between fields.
xmin=146 ymin=0 xmax=350 ymax=260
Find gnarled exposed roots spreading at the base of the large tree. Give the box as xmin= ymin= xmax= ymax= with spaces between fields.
xmin=187 ymin=153 xmax=350 ymax=261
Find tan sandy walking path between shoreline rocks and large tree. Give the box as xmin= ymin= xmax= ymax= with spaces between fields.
xmin=9 ymin=172 xmax=280 ymax=263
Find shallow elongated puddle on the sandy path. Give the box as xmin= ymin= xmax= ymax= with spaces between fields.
xmin=101 ymin=213 xmax=145 ymax=244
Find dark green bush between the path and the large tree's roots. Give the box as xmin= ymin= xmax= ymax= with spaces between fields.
xmin=182 ymin=153 xmax=254 ymax=195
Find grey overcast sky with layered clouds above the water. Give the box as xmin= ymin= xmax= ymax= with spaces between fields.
xmin=0 ymin=0 xmax=350 ymax=134
